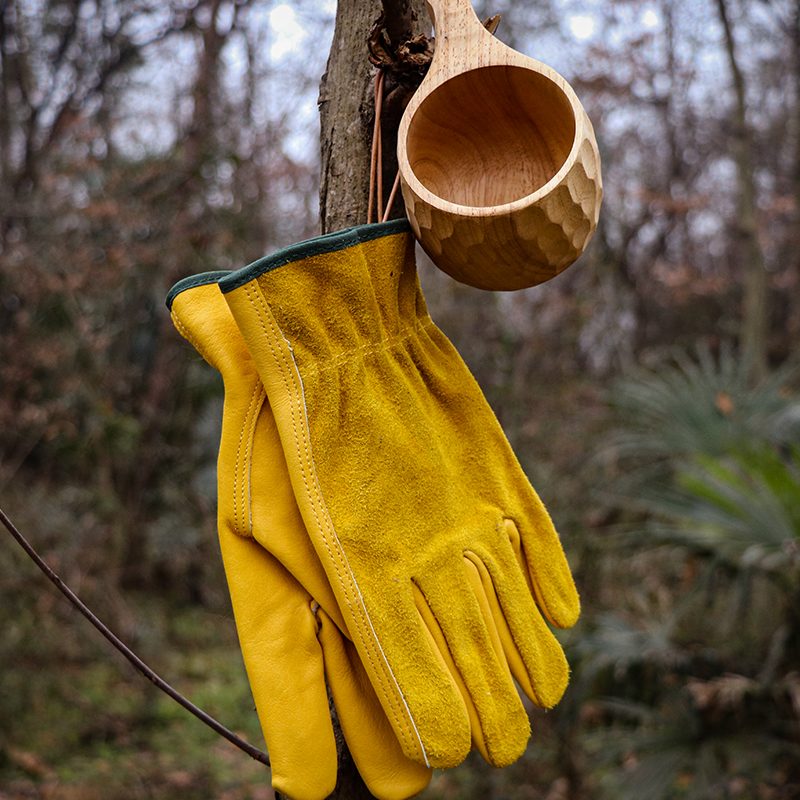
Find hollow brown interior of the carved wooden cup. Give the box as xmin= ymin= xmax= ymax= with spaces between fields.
xmin=406 ymin=65 xmax=575 ymax=207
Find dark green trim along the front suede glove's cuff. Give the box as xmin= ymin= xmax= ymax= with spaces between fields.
xmin=219 ymin=217 xmax=411 ymax=294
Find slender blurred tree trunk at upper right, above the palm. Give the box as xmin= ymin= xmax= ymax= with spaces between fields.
xmin=717 ymin=0 xmax=769 ymax=381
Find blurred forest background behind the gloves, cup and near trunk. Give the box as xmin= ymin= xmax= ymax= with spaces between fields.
xmin=0 ymin=0 xmax=800 ymax=800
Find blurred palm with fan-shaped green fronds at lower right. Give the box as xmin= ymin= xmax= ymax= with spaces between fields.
xmin=576 ymin=349 xmax=800 ymax=800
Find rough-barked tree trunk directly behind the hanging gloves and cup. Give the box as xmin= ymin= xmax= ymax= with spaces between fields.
xmin=319 ymin=0 xmax=429 ymax=800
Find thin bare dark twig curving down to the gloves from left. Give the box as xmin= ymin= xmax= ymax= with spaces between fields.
xmin=0 ymin=509 xmax=269 ymax=766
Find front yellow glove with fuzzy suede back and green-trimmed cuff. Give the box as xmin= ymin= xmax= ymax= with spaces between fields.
xmin=220 ymin=220 xmax=579 ymax=768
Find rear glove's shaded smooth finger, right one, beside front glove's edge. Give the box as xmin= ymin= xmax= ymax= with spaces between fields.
xmin=317 ymin=608 xmax=433 ymax=800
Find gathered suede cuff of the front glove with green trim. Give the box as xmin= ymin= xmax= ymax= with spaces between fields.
xmin=219 ymin=220 xmax=431 ymax=375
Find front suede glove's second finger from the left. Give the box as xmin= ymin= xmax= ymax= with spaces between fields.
xmin=417 ymin=560 xmax=530 ymax=767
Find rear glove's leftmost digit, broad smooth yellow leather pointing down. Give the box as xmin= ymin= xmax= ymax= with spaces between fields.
xmin=220 ymin=528 xmax=337 ymax=800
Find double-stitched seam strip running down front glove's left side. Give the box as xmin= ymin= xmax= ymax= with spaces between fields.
xmin=242 ymin=283 xmax=430 ymax=767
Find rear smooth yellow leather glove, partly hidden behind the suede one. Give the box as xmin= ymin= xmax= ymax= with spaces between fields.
xmin=167 ymin=274 xmax=431 ymax=800
